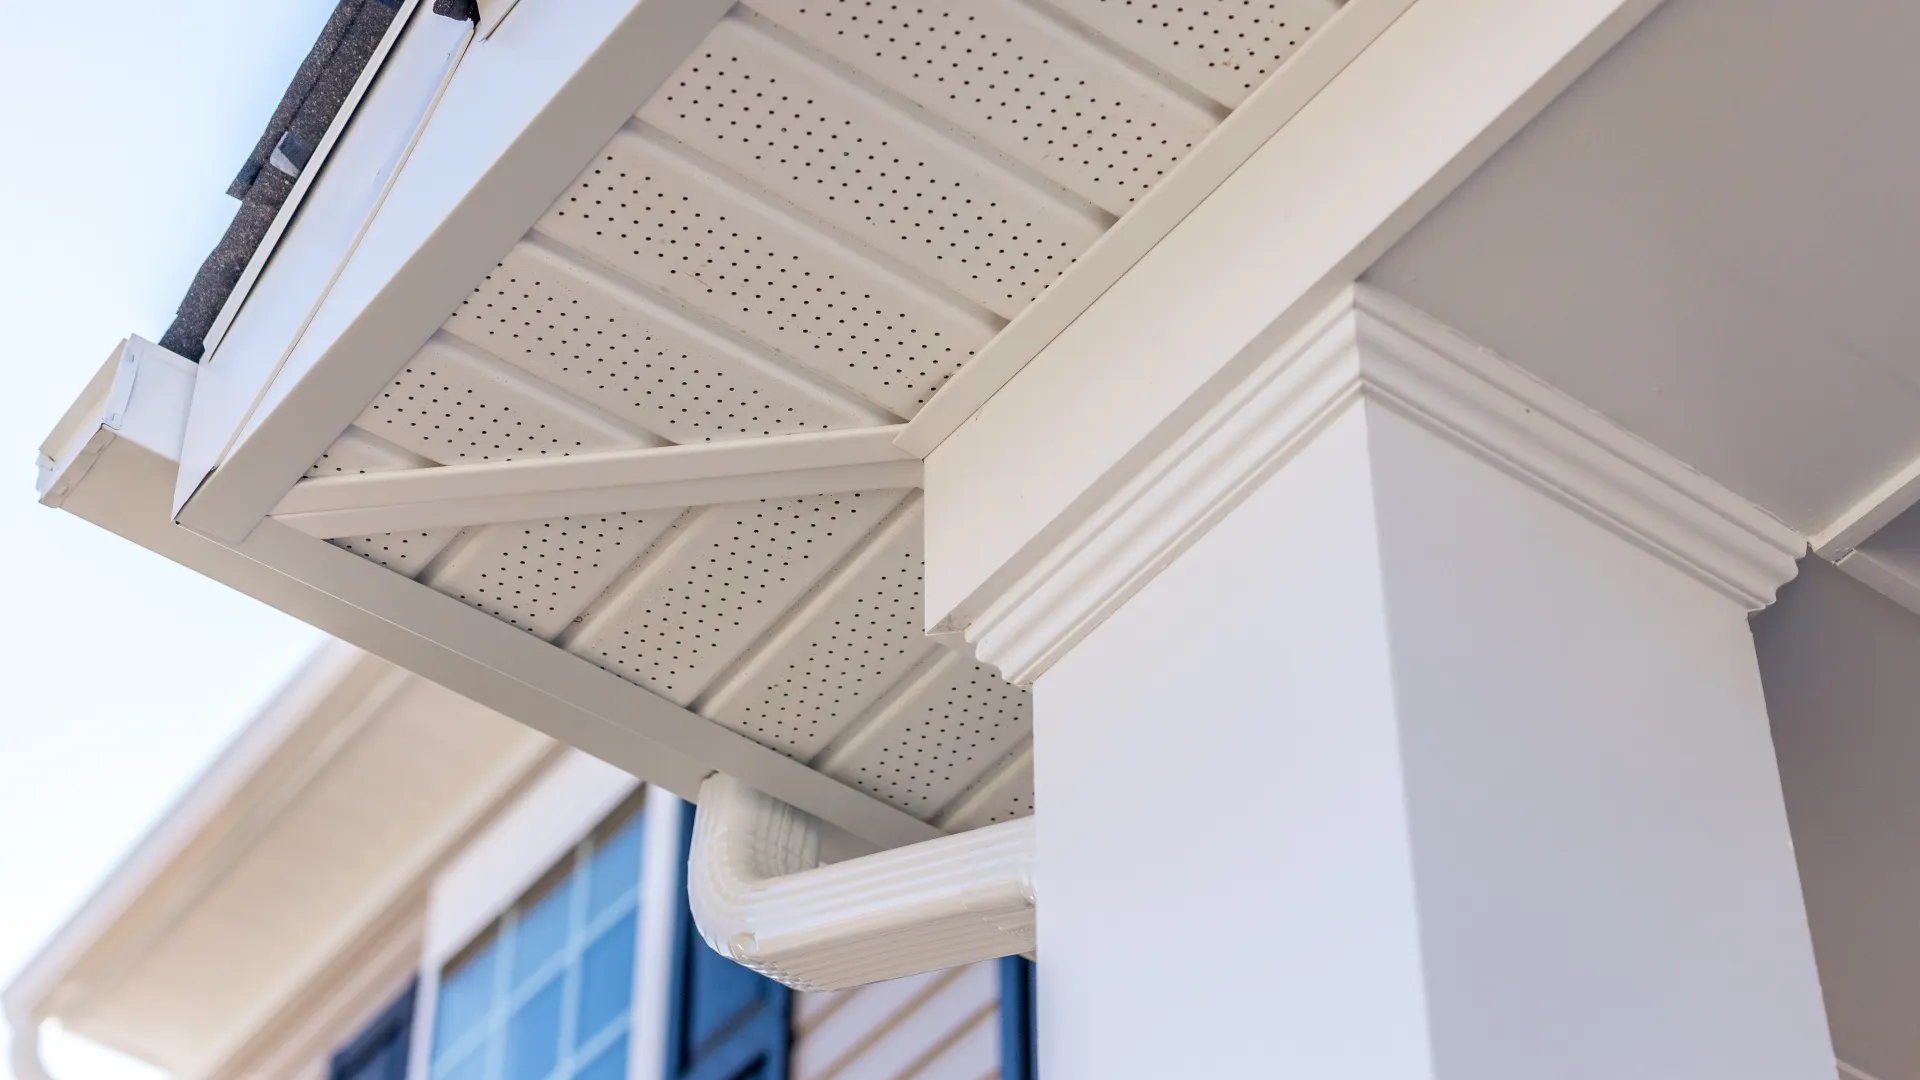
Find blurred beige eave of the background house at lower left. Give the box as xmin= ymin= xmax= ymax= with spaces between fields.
xmin=6 ymin=638 xmax=553 ymax=1078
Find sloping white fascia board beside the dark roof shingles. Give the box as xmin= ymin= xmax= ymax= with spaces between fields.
xmin=173 ymin=0 xmax=732 ymax=542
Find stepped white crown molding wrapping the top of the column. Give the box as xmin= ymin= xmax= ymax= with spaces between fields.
xmin=966 ymin=284 xmax=1807 ymax=684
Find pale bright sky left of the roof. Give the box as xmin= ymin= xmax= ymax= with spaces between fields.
xmin=0 ymin=0 xmax=332 ymax=1080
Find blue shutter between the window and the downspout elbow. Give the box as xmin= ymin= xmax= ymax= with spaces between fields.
xmin=666 ymin=807 xmax=793 ymax=1080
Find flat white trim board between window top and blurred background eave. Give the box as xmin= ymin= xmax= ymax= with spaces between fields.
xmin=420 ymin=749 xmax=639 ymax=970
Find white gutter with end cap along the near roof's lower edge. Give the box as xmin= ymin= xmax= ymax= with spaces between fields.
xmin=42 ymin=336 xmax=941 ymax=847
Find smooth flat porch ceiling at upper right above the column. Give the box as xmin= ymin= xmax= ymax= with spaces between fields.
xmin=1369 ymin=0 xmax=1920 ymax=534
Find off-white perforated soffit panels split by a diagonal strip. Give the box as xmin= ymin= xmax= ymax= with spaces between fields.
xmin=309 ymin=0 xmax=1338 ymax=830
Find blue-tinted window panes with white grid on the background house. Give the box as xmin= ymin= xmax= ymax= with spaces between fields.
xmin=428 ymin=801 xmax=641 ymax=1080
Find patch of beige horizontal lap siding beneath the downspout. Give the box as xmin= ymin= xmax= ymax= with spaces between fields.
xmin=793 ymin=961 xmax=1000 ymax=1080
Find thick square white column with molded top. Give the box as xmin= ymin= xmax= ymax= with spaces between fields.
xmin=929 ymin=294 xmax=1834 ymax=1080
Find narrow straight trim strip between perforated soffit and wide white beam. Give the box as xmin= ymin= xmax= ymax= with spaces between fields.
xmin=899 ymin=0 xmax=1413 ymax=457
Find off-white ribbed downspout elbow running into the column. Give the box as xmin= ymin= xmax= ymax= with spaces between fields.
xmin=687 ymin=774 xmax=1035 ymax=990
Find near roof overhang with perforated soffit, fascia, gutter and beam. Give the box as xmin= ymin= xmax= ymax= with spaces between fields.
xmin=33 ymin=0 xmax=1655 ymax=847
